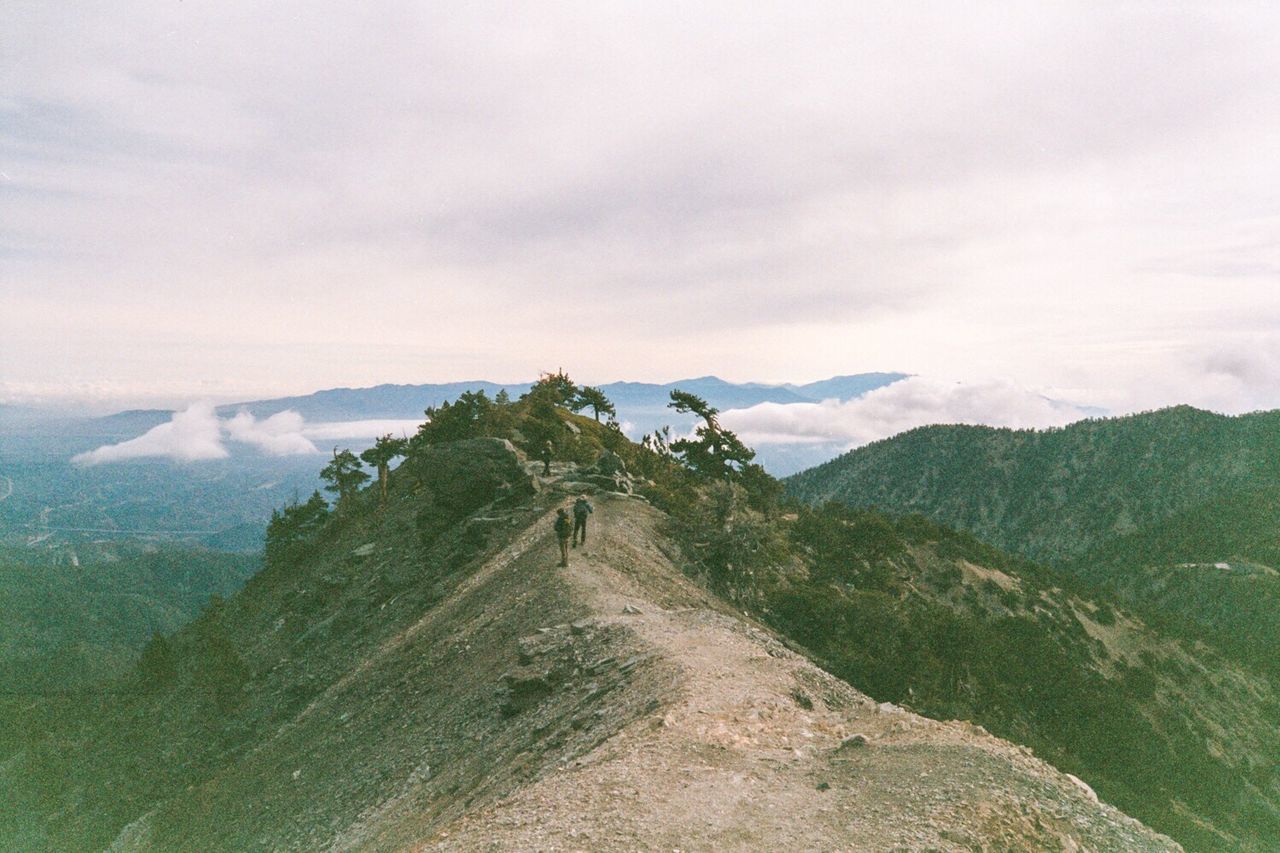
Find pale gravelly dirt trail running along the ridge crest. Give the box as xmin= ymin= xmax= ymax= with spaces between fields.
xmin=421 ymin=496 xmax=1178 ymax=850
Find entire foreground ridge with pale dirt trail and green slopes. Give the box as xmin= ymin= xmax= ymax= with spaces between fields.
xmin=0 ymin=406 xmax=1198 ymax=850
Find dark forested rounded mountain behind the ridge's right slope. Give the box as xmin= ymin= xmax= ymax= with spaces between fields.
xmin=787 ymin=406 xmax=1280 ymax=565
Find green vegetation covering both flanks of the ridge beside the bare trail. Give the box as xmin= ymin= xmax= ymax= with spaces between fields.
xmin=0 ymin=371 xmax=1280 ymax=849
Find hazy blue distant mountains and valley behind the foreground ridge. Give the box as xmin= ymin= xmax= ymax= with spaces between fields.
xmin=0 ymin=373 xmax=906 ymax=551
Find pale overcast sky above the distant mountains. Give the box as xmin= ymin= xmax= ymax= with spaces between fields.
xmin=0 ymin=0 xmax=1280 ymax=411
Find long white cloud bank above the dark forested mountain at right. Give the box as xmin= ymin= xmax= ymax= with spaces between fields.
xmin=721 ymin=377 xmax=1088 ymax=447
